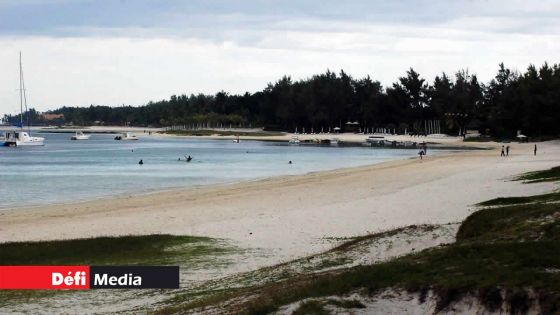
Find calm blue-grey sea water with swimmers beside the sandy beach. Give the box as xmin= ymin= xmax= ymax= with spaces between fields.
xmin=0 ymin=134 xmax=417 ymax=208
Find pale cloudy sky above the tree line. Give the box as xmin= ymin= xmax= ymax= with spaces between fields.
xmin=0 ymin=0 xmax=560 ymax=115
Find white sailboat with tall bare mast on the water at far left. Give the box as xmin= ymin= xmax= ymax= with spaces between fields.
xmin=4 ymin=51 xmax=45 ymax=147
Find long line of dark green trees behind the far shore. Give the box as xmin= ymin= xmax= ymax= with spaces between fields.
xmin=6 ymin=63 xmax=560 ymax=138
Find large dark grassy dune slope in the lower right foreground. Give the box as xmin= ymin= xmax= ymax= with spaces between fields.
xmin=155 ymin=171 xmax=560 ymax=314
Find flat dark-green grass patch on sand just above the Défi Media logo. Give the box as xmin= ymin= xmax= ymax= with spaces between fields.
xmin=0 ymin=235 xmax=225 ymax=265
